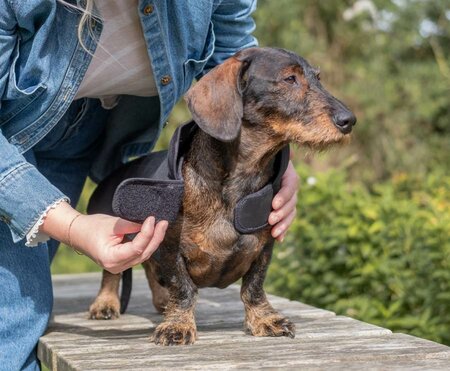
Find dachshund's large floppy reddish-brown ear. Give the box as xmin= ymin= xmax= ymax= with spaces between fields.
xmin=184 ymin=53 xmax=253 ymax=142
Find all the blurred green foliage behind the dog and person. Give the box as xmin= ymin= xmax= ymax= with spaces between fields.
xmin=52 ymin=0 xmax=450 ymax=345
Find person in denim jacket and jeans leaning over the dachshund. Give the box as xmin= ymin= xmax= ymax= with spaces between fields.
xmin=0 ymin=0 xmax=298 ymax=370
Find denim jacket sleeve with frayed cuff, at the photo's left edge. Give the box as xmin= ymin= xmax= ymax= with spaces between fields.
xmin=0 ymin=0 xmax=66 ymax=248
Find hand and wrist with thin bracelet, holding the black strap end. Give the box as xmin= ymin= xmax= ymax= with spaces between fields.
xmin=39 ymin=202 xmax=168 ymax=274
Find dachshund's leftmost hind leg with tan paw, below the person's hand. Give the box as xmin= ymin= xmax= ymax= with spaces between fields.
xmin=89 ymin=270 xmax=121 ymax=319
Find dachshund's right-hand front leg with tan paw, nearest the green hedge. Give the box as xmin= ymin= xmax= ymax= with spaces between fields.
xmin=241 ymin=240 xmax=295 ymax=338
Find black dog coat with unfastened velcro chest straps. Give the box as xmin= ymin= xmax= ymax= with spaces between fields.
xmin=88 ymin=121 xmax=289 ymax=233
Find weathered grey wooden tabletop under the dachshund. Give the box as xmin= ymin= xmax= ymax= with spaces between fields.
xmin=38 ymin=271 xmax=450 ymax=371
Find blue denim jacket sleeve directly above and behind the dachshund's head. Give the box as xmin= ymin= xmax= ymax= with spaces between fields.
xmin=203 ymin=0 xmax=258 ymax=75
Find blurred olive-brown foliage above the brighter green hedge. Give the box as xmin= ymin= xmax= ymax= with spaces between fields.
xmin=255 ymin=0 xmax=450 ymax=181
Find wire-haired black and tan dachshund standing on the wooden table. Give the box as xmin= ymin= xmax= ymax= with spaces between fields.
xmin=90 ymin=48 xmax=356 ymax=345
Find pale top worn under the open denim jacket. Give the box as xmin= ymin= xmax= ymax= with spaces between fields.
xmin=75 ymin=0 xmax=158 ymax=108
